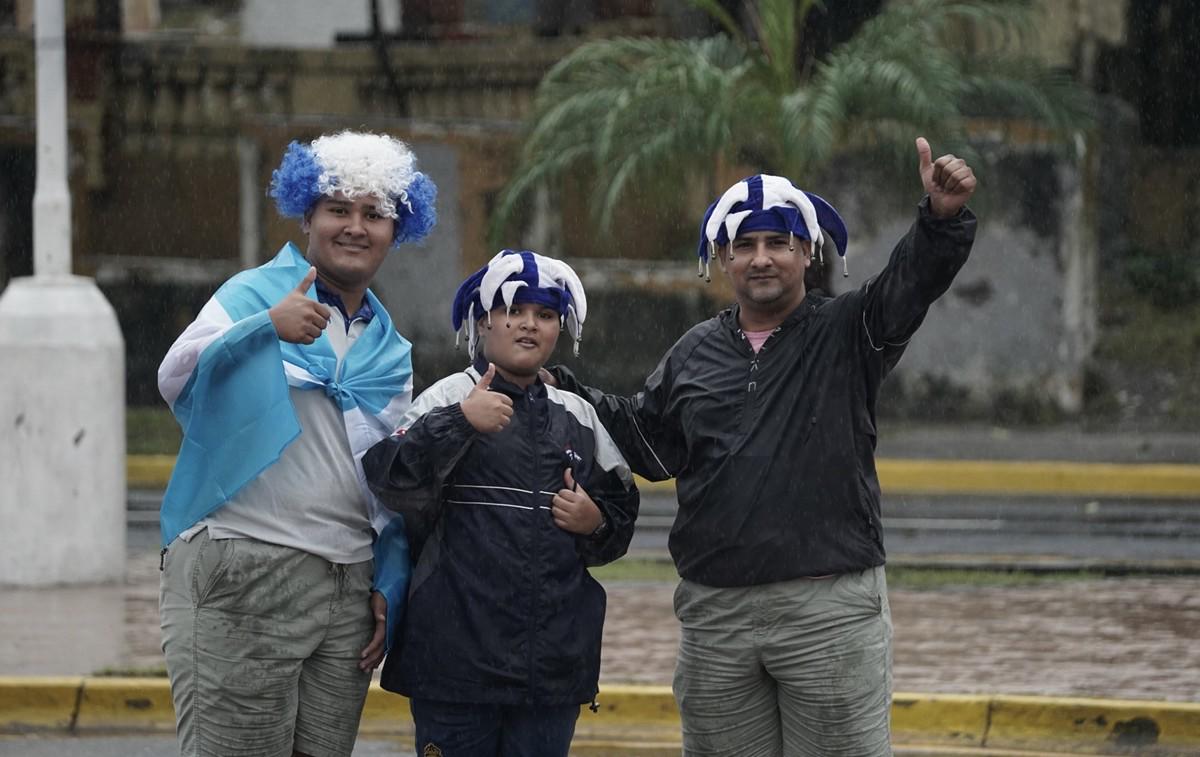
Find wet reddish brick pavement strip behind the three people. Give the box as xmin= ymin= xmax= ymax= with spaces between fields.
xmin=0 ymin=554 xmax=1200 ymax=702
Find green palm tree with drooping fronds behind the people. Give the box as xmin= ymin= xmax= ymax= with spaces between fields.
xmin=492 ymin=0 xmax=1090 ymax=236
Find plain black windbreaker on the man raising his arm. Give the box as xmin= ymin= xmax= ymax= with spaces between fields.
xmin=553 ymin=198 xmax=976 ymax=587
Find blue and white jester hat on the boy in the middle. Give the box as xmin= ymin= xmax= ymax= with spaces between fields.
xmin=450 ymin=250 xmax=588 ymax=355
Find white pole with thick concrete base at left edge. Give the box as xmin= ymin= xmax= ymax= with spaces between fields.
xmin=0 ymin=0 xmax=125 ymax=585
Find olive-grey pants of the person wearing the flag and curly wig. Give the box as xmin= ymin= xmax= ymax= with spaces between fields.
xmin=158 ymin=530 xmax=374 ymax=757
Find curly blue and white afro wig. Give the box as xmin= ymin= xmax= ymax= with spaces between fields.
xmin=269 ymin=131 xmax=438 ymax=247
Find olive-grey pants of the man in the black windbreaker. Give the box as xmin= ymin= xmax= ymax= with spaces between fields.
xmin=674 ymin=567 xmax=892 ymax=757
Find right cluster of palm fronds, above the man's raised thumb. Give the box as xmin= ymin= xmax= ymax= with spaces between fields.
xmin=782 ymin=0 xmax=1090 ymax=170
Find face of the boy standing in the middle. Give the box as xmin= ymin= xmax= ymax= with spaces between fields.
xmin=479 ymin=302 xmax=559 ymax=383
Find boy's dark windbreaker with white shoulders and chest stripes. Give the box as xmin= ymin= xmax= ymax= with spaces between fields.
xmin=362 ymin=362 xmax=638 ymax=705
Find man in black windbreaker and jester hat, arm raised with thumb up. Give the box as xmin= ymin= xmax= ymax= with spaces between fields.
xmin=553 ymin=139 xmax=976 ymax=757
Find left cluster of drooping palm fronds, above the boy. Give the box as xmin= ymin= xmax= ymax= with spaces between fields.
xmin=492 ymin=37 xmax=754 ymax=234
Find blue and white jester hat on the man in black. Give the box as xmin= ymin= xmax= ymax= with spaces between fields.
xmin=696 ymin=174 xmax=848 ymax=280
